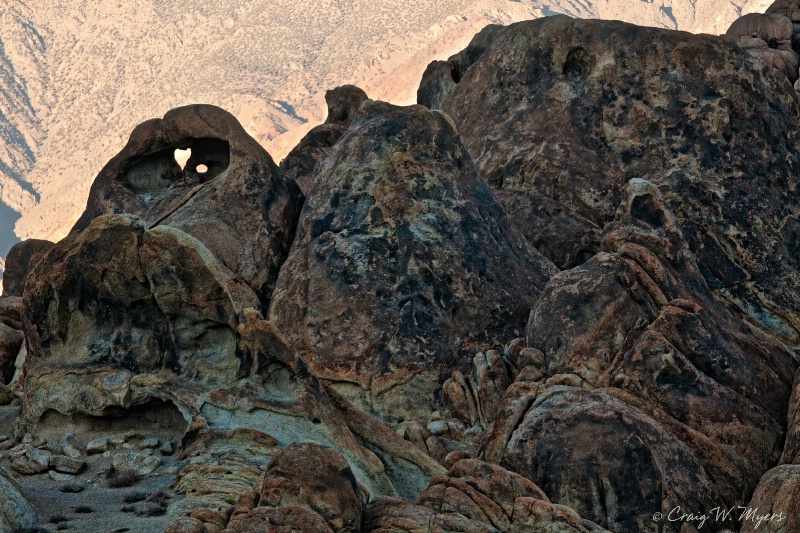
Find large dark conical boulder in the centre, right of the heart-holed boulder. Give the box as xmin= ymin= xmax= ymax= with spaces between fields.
xmin=270 ymin=101 xmax=555 ymax=419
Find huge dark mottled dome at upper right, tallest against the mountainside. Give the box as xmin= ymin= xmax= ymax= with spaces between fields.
xmin=418 ymin=16 xmax=800 ymax=346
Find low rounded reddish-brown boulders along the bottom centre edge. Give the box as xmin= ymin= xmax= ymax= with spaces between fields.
xmin=180 ymin=454 xmax=605 ymax=533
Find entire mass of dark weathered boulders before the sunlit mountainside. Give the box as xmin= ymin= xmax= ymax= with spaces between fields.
xmin=7 ymin=9 xmax=800 ymax=533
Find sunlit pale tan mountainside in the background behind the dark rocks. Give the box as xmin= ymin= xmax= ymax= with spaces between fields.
xmin=0 ymin=0 xmax=769 ymax=275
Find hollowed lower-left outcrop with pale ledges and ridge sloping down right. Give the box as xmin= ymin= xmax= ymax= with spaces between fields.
xmin=19 ymin=211 xmax=443 ymax=516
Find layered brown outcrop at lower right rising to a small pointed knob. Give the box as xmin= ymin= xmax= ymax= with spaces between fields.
xmin=481 ymin=180 xmax=797 ymax=531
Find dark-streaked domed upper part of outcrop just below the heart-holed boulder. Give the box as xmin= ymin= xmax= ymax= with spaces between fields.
xmin=24 ymin=215 xmax=258 ymax=386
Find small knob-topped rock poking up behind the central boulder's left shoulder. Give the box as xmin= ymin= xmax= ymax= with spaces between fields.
xmin=281 ymin=85 xmax=367 ymax=194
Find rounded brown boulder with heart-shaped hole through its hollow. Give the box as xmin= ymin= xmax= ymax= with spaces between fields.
xmin=72 ymin=105 xmax=302 ymax=305
